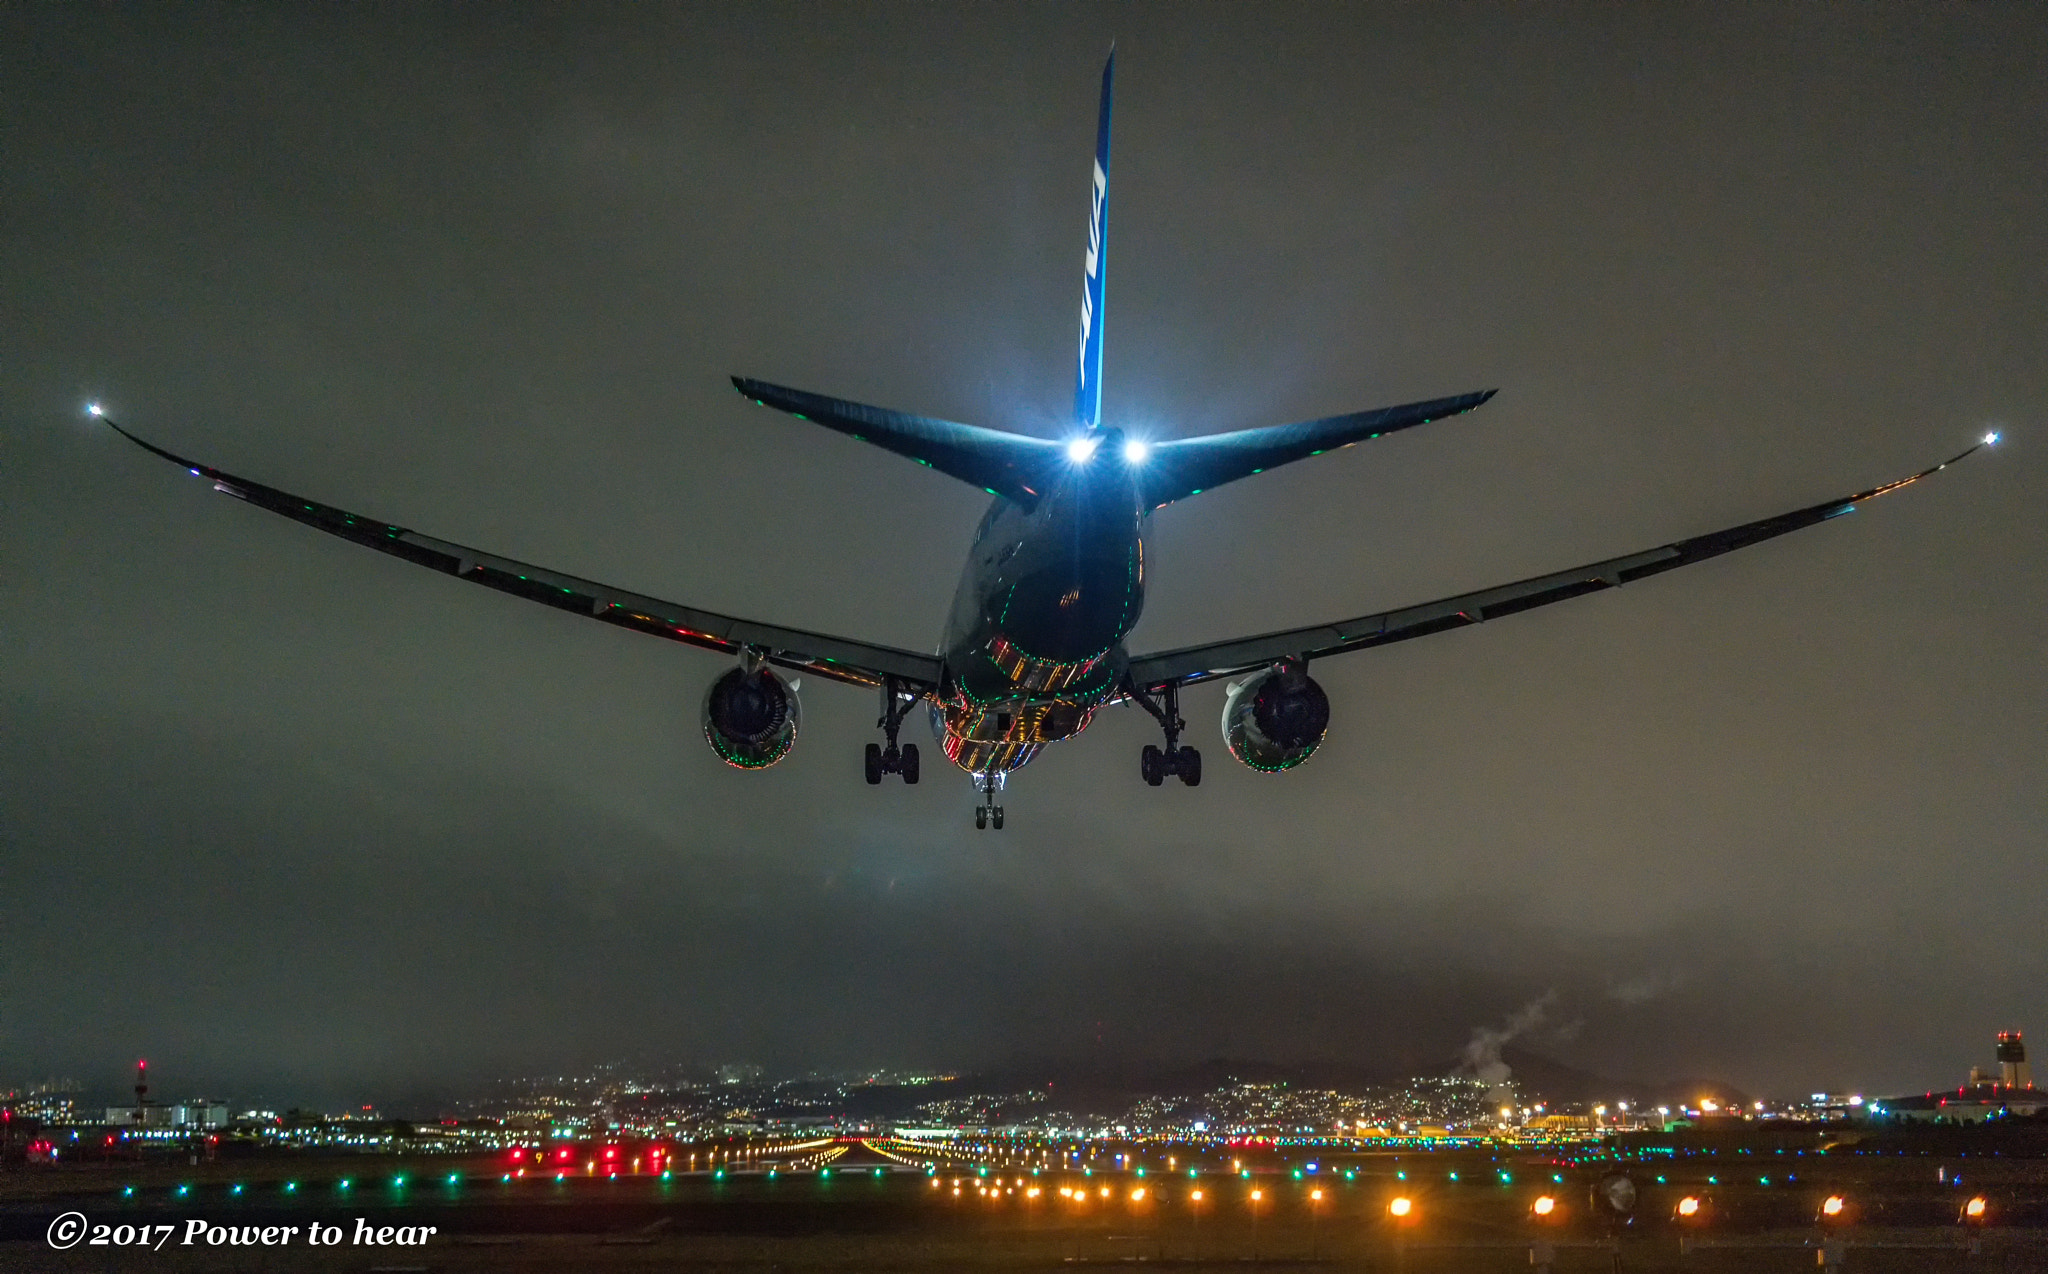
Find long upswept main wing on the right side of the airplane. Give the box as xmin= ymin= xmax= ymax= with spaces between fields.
xmin=1130 ymin=434 xmax=1997 ymax=690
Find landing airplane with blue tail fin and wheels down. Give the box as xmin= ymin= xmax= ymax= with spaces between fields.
xmin=88 ymin=47 xmax=1997 ymax=830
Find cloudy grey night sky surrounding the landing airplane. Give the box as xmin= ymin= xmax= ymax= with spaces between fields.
xmin=0 ymin=4 xmax=2048 ymax=1102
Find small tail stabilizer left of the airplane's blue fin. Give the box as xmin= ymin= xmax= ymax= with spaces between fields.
xmin=733 ymin=377 xmax=1061 ymax=504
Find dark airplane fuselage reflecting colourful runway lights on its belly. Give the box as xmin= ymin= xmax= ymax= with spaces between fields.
xmin=934 ymin=457 xmax=1145 ymax=774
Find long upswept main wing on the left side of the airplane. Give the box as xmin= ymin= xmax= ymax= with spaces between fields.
xmin=94 ymin=412 xmax=940 ymax=692
